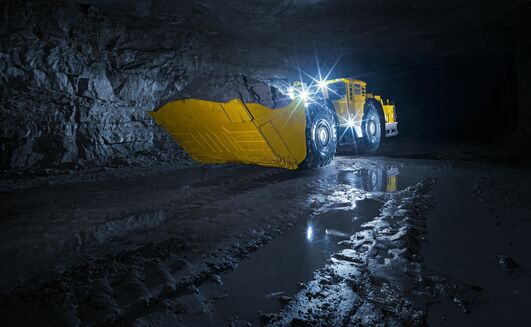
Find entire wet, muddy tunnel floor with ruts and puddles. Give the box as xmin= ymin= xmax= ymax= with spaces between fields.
xmin=0 ymin=157 xmax=531 ymax=326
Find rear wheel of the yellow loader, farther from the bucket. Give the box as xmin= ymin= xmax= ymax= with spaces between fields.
xmin=359 ymin=101 xmax=385 ymax=153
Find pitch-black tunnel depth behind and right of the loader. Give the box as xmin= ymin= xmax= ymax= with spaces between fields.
xmin=365 ymin=54 xmax=518 ymax=143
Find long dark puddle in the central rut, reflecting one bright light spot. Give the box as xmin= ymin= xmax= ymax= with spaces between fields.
xmin=216 ymin=199 xmax=382 ymax=324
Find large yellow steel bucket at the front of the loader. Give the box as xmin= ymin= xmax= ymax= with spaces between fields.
xmin=150 ymin=99 xmax=306 ymax=169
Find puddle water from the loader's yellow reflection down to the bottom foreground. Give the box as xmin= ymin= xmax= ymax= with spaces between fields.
xmin=215 ymin=167 xmax=424 ymax=325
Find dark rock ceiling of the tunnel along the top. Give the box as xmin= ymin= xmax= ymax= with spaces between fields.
xmin=76 ymin=0 xmax=524 ymax=58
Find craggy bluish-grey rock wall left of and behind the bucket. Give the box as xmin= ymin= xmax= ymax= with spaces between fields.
xmin=0 ymin=1 xmax=294 ymax=169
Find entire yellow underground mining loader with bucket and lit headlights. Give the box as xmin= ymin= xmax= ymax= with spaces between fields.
xmin=150 ymin=78 xmax=398 ymax=170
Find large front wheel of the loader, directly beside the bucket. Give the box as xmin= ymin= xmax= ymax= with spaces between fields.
xmin=300 ymin=104 xmax=337 ymax=169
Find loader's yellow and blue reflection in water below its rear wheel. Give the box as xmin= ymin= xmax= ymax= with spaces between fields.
xmin=338 ymin=167 xmax=399 ymax=192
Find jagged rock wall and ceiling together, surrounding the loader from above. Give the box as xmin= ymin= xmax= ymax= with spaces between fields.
xmin=0 ymin=0 xmax=531 ymax=169
